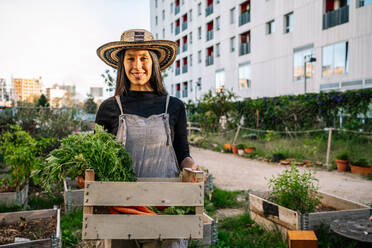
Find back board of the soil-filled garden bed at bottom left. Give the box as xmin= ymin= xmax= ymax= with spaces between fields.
xmin=0 ymin=209 xmax=57 ymax=224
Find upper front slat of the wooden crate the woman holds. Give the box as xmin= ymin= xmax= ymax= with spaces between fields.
xmin=84 ymin=181 xmax=204 ymax=206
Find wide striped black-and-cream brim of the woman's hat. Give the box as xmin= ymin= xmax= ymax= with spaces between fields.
xmin=97 ymin=40 xmax=178 ymax=70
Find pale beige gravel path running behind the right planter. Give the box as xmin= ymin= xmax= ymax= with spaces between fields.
xmin=190 ymin=147 xmax=372 ymax=205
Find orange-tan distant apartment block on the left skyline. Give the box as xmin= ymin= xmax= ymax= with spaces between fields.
xmin=12 ymin=77 xmax=42 ymax=103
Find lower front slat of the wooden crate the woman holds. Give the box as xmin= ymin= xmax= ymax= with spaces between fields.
xmin=83 ymin=214 xmax=203 ymax=239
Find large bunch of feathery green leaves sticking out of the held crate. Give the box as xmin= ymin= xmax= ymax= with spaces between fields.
xmin=43 ymin=125 xmax=136 ymax=190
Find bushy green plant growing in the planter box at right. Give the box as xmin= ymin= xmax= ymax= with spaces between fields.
xmin=268 ymin=164 xmax=321 ymax=213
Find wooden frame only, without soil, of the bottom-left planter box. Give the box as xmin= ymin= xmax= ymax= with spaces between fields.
xmin=0 ymin=208 xmax=62 ymax=248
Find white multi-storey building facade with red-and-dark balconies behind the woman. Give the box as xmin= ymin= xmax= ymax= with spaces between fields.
xmin=150 ymin=0 xmax=372 ymax=101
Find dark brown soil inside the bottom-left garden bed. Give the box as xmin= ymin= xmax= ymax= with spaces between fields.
xmin=0 ymin=217 xmax=57 ymax=245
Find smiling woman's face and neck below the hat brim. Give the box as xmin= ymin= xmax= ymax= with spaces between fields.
xmin=124 ymin=49 xmax=152 ymax=90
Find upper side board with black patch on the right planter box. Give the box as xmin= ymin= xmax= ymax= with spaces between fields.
xmin=249 ymin=194 xmax=299 ymax=230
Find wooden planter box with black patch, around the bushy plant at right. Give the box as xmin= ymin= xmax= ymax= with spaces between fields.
xmin=249 ymin=192 xmax=370 ymax=235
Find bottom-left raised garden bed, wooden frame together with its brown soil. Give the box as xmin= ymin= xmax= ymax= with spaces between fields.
xmin=0 ymin=209 xmax=62 ymax=248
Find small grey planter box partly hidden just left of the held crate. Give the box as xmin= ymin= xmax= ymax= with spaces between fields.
xmin=63 ymin=178 xmax=84 ymax=213
